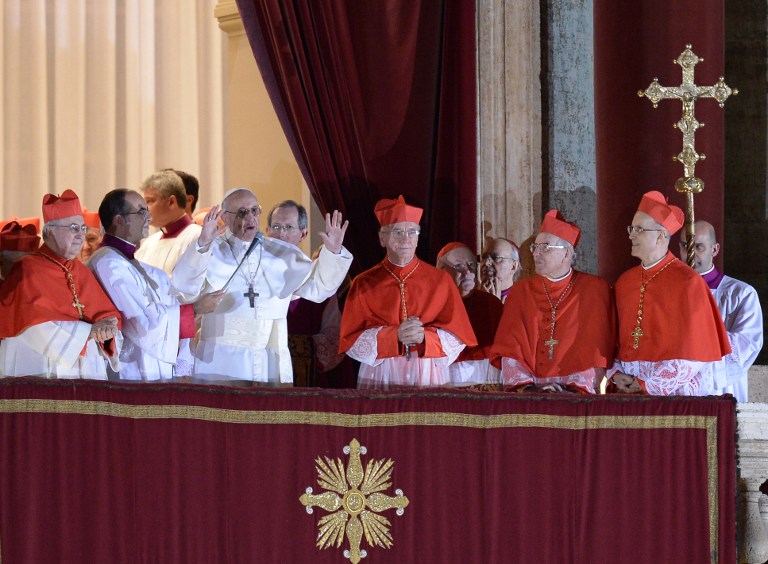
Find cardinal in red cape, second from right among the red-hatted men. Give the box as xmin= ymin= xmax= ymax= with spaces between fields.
xmin=493 ymin=210 xmax=616 ymax=394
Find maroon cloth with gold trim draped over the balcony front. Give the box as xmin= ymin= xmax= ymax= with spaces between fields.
xmin=0 ymin=379 xmax=736 ymax=564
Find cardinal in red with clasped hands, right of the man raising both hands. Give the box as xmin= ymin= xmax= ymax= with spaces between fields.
xmin=339 ymin=196 xmax=477 ymax=389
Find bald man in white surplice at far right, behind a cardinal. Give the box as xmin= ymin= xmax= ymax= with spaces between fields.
xmin=680 ymin=221 xmax=763 ymax=401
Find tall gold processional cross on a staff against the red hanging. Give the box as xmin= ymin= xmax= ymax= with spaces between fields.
xmin=637 ymin=45 xmax=739 ymax=267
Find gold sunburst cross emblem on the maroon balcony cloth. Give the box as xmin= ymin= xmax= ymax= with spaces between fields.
xmin=299 ymin=439 xmax=408 ymax=564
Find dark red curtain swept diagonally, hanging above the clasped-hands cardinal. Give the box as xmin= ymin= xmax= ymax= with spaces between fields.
xmin=237 ymin=0 xmax=476 ymax=271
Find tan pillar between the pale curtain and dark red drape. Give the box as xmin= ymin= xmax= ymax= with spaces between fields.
xmin=214 ymin=0 xmax=312 ymax=253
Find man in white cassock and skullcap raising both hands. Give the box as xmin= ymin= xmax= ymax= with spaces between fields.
xmin=173 ymin=188 xmax=352 ymax=385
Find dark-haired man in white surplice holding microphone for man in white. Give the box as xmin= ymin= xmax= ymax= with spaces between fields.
xmin=88 ymin=189 xmax=221 ymax=381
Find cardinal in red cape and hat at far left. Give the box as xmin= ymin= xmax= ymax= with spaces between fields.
xmin=0 ymin=190 xmax=122 ymax=380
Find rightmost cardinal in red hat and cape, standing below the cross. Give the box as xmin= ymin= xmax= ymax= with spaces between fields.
xmin=608 ymin=191 xmax=731 ymax=396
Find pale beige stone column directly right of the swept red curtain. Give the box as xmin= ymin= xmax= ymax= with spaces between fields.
xmin=477 ymin=0 xmax=541 ymax=256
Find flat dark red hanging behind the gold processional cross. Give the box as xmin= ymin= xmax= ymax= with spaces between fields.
xmin=594 ymin=0 xmax=738 ymax=282
